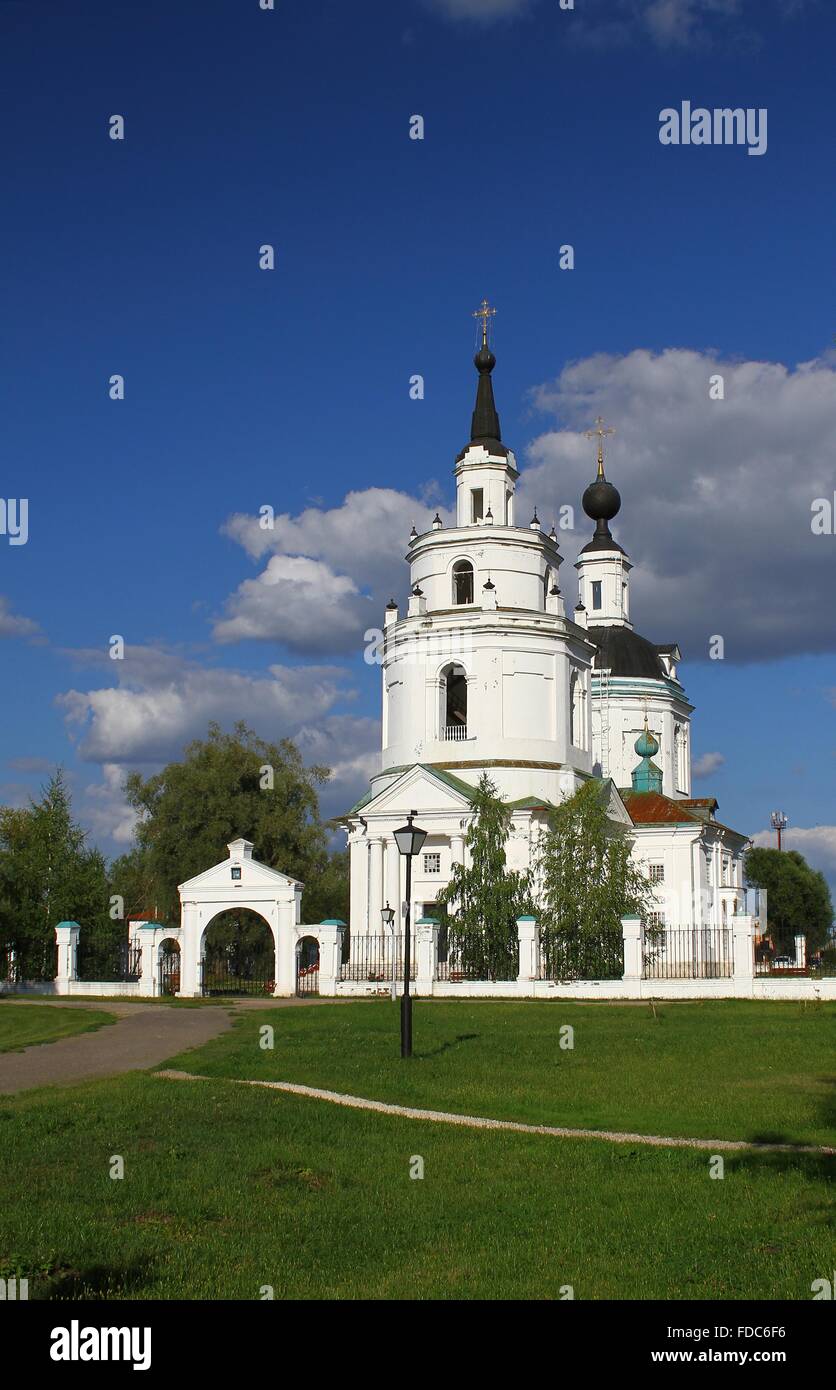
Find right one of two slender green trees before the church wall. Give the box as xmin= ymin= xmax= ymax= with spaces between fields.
xmin=536 ymin=780 xmax=655 ymax=979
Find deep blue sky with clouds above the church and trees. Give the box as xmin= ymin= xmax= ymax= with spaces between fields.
xmin=0 ymin=0 xmax=836 ymax=880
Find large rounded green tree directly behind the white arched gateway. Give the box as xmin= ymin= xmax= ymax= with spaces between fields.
xmin=122 ymin=724 xmax=328 ymax=922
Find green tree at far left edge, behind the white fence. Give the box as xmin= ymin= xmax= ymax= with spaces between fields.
xmin=0 ymin=770 xmax=111 ymax=979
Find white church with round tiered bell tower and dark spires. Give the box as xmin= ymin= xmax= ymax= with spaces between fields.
xmin=344 ymin=304 xmax=747 ymax=940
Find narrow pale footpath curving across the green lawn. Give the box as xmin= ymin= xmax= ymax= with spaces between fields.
xmin=154 ymin=1072 xmax=836 ymax=1155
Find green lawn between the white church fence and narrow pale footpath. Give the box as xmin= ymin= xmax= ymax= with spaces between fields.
xmin=164 ymin=999 xmax=836 ymax=1144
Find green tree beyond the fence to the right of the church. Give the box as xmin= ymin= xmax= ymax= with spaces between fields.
xmin=744 ymin=847 xmax=833 ymax=951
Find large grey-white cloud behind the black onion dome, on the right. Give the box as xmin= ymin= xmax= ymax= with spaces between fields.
xmin=520 ymin=349 xmax=836 ymax=662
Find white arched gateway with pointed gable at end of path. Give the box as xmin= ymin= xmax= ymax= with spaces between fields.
xmin=178 ymin=840 xmax=303 ymax=998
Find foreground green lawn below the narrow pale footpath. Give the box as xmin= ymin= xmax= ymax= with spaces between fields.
xmin=0 ymin=1074 xmax=833 ymax=1300
